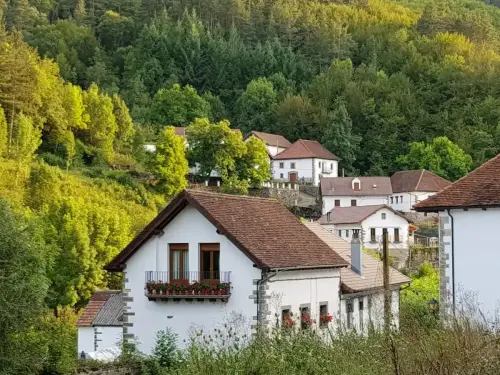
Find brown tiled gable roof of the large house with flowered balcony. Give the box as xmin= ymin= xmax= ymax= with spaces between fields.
xmin=106 ymin=190 xmax=346 ymax=271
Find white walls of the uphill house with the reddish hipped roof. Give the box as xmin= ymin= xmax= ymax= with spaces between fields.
xmin=271 ymin=158 xmax=338 ymax=186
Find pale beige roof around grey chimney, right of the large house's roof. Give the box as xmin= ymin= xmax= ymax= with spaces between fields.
xmin=304 ymin=222 xmax=411 ymax=293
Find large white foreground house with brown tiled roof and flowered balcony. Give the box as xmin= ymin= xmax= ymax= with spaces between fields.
xmin=102 ymin=190 xmax=348 ymax=353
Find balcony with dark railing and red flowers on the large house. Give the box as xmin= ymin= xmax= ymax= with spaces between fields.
xmin=144 ymin=271 xmax=231 ymax=302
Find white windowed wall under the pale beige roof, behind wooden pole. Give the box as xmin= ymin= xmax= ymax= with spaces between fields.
xmin=340 ymin=290 xmax=399 ymax=335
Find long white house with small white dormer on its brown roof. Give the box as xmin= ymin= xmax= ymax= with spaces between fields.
xmin=320 ymin=177 xmax=392 ymax=214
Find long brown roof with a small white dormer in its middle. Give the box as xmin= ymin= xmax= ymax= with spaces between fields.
xmin=320 ymin=177 xmax=392 ymax=196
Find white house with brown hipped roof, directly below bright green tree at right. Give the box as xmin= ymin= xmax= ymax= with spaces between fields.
xmin=389 ymin=169 xmax=451 ymax=212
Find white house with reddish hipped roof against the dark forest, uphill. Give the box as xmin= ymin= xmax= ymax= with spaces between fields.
xmin=271 ymin=139 xmax=339 ymax=186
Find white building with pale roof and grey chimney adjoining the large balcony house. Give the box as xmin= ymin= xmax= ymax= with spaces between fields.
xmin=304 ymin=222 xmax=411 ymax=334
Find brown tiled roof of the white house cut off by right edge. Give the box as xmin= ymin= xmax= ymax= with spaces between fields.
xmin=414 ymin=154 xmax=500 ymax=211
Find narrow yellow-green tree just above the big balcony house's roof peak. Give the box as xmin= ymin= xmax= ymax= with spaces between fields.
xmin=152 ymin=126 xmax=189 ymax=197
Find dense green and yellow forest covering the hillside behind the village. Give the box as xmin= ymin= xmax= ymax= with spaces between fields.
xmin=0 ymin=0 xmax=500 ymax=373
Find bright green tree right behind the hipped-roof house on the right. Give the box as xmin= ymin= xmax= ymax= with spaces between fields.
xmin=397 ymin=137 xmax=472 ymax=181
